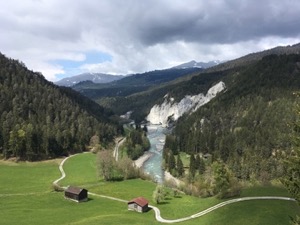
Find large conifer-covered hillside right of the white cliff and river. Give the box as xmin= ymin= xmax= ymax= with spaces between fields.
xmin=173 ymin=55 xmax=300 ymax=181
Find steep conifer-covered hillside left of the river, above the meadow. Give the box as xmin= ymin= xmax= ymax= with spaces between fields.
xmin=0 ymin=54 xmax=118 ymax=160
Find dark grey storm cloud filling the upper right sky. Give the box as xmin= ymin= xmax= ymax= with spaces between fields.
xmin=132 ymin=0 xmax=300 ymax=45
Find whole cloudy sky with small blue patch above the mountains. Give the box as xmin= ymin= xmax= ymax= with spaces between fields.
xmin=0 ymin=0 xmax=300 ymax=81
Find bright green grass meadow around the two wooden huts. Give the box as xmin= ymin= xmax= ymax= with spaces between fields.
xmin=0 ymin=154 xmax=300 ymax=225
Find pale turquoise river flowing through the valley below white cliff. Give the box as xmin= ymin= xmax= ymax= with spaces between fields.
xmin=143 ymin=125 xmax=168 ymax=183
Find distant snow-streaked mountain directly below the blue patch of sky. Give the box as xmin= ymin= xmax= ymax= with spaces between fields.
xmin=55 ymin=73 xmax=124 ymax=87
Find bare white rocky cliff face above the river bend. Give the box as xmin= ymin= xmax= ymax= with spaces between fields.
xmin=147 ymin=81 xmax=226 ymax=126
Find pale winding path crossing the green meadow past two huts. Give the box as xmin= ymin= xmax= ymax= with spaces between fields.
xmin=53 ymin=154 xmax=296 ymax=223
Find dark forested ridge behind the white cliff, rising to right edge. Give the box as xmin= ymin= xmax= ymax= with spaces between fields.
xmin=95 ymin=44 xmax=300 ymax=124
